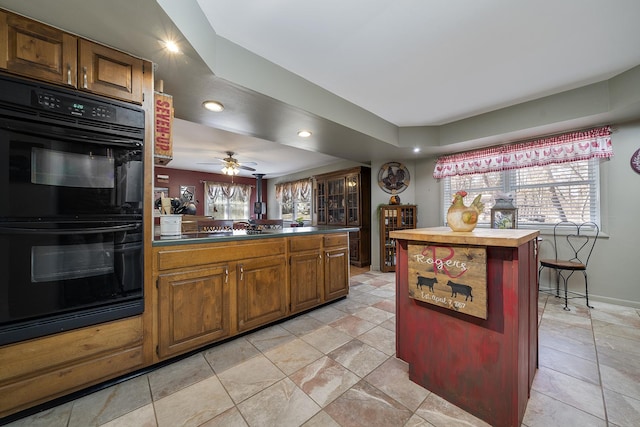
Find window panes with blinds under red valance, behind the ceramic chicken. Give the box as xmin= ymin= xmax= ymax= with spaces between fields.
xmin=443 ymin=158 xmax=600 ymax=228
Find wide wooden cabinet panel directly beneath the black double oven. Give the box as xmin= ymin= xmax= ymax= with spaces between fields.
xmin=0 ymin=316 xmax=145 ymax=418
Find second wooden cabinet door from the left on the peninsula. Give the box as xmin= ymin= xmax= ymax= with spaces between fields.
xmin=236 ymin=256 xmax=287 ymax=331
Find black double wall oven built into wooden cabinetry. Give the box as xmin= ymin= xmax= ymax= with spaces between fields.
xmin=0 ymin=75 xmax=145 ymax=345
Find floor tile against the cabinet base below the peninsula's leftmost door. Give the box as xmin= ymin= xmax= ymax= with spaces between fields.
xmin=148 ymin=353 xmax=214 ymax=401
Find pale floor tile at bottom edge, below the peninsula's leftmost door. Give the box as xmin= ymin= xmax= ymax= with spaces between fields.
xmin=154 ymin=377 xmax=233 ymax=427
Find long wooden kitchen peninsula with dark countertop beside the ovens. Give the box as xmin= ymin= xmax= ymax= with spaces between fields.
xmin=152 ymin=227 xmax=353 ymax=361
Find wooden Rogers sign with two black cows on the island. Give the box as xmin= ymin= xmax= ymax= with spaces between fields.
xmin=407 ymin=244 xmax=487 ymax=319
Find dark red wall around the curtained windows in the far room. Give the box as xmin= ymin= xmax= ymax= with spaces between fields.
xmin=153 ymin=166 xmax=267 ymax=218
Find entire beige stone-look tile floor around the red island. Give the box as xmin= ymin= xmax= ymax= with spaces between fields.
xmin=5 ymin=272 xmax=640 ymax=427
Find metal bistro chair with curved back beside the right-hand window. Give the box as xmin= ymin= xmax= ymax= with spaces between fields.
xmin=538 ymin=221 xmax=600 ymax=311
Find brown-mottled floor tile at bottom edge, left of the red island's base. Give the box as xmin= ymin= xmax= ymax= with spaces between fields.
xmin=325 ymin=381 xmax=412 ymax=427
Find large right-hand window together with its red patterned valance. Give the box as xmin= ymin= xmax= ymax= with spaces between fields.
xmin=433 ymin=126 xmax=613 ymax=228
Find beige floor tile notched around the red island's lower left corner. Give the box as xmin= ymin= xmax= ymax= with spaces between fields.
xmin=365 ymin=357 xmax=430 ymax=412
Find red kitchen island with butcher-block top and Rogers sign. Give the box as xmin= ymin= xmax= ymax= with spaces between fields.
xmin=390 ymin=227 xmax=539 ymax=427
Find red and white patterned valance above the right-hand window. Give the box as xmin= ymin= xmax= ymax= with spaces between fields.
xmin=433 ymin=126 xmax=613 ymax=179
